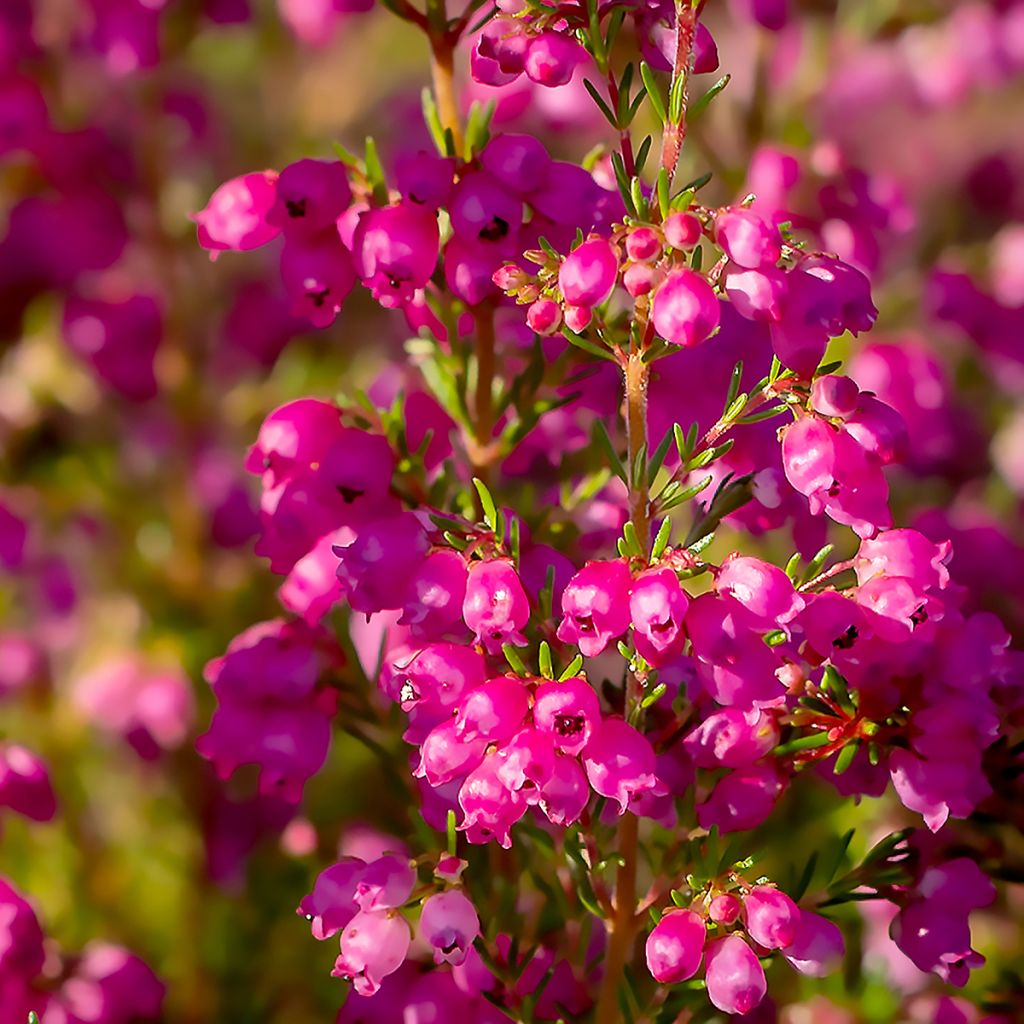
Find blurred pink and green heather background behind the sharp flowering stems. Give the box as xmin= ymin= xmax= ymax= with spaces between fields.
xmin=6 ymin=0 xmax=1024 ymax=1024
